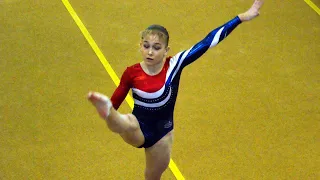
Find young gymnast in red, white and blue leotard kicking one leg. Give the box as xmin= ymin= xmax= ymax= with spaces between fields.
xmin=88 ymin=0 xmax=263 ymax=180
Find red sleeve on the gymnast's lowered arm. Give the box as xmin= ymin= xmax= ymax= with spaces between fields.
xmin=111 ymin=68 xmax=132 ymax=109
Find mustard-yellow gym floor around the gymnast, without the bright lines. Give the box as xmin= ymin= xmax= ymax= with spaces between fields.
xmin=0 ymin=0 xmax=320 ymax=180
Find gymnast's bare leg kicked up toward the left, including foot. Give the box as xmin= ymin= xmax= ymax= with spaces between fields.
xmin=88 ymin=92 xmax=144 ymax=147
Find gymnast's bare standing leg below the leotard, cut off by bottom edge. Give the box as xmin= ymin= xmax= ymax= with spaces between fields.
xmin=145 ymin=131 xmax=173 ymax=180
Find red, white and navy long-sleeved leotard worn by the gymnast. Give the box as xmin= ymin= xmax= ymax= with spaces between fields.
xmin=111 ymin=16 xmax=241 ymax=148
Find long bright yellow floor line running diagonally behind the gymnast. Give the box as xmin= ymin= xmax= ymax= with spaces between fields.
xmin=62 ymin=0 xmax=184 ymax=180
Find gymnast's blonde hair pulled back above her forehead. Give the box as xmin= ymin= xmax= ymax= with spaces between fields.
xmin=140 ymin=24 xmax=169 ymax=47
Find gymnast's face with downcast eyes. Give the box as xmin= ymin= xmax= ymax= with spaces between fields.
xmin=140 ymin=33 xmax=169 ymax=66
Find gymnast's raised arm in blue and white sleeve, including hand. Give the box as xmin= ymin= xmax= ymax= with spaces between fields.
xmin=173 ymin=0 xmax=263 ymax=68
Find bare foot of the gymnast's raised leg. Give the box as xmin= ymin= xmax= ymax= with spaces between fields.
xmin=88 ymin=92 xmax=112 ymax=119
